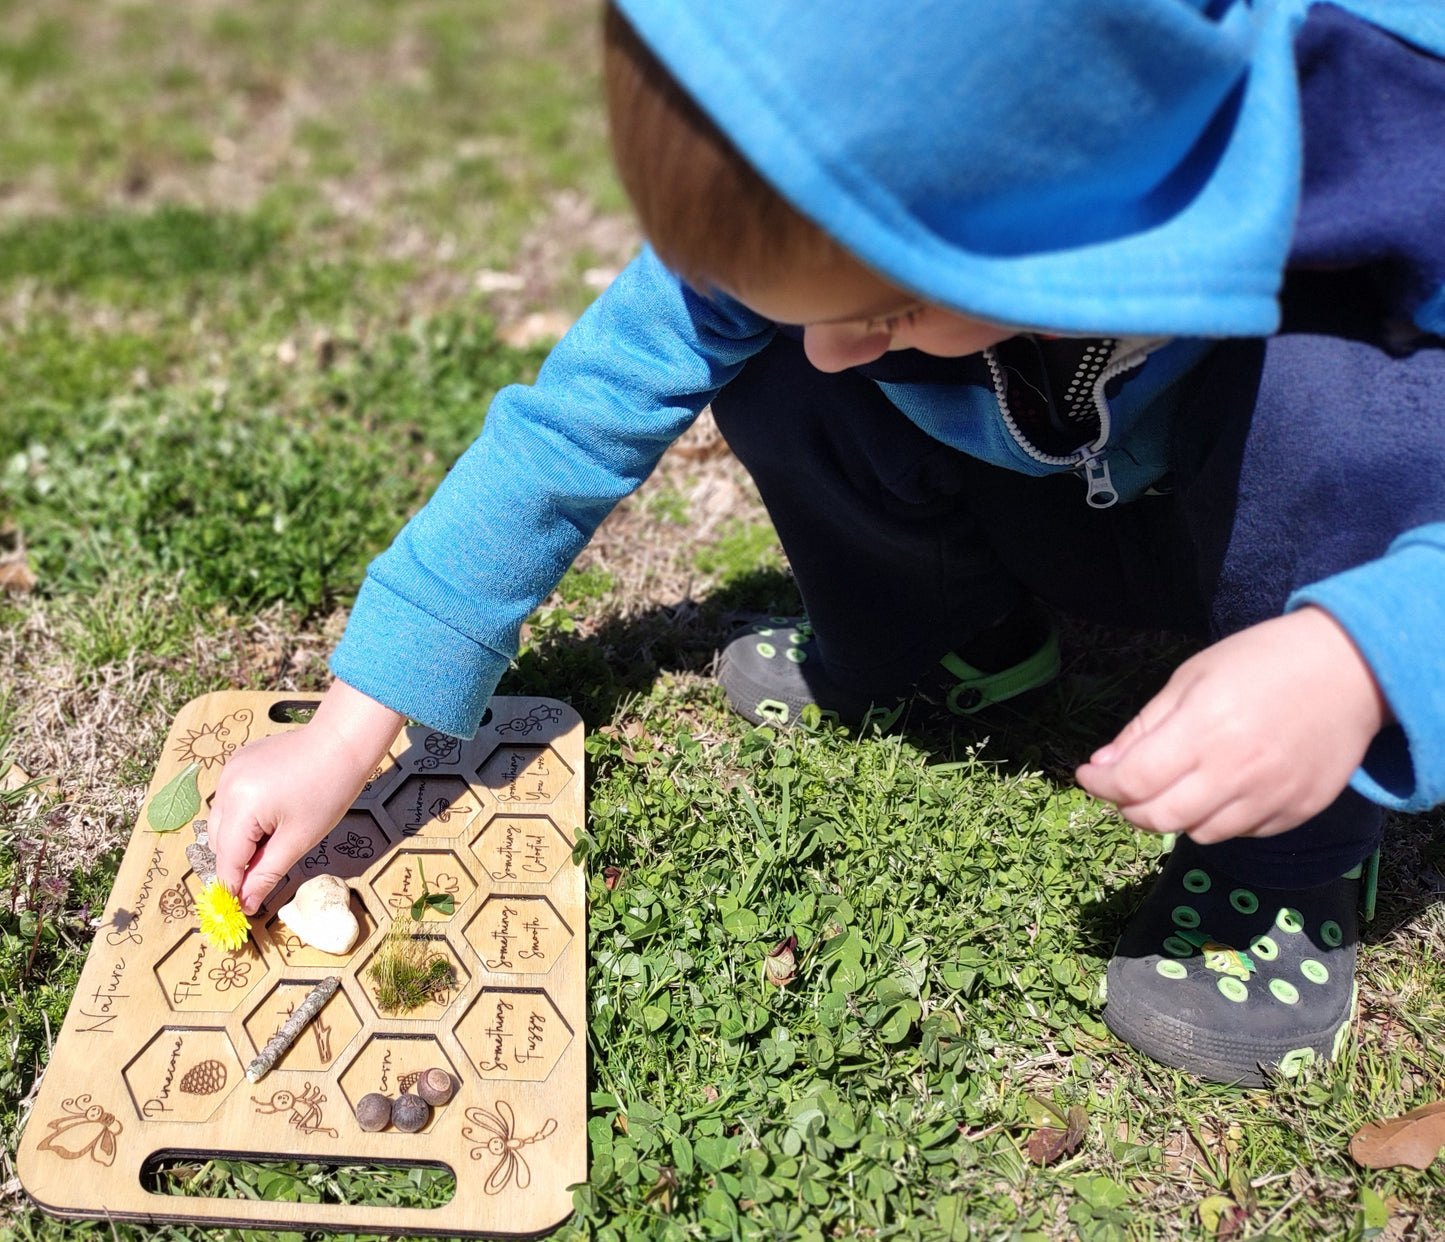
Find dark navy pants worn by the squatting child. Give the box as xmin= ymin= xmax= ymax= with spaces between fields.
xmin=712 ymin=335 xmax=1445 ymax=888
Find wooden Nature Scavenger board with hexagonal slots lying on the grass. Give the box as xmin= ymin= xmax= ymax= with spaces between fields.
xmin=19 ymin=692 xmax=587 ymax=1236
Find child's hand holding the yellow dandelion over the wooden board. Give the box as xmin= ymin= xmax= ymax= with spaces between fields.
xmin=210 ymin=682 xmax=405 ymax=914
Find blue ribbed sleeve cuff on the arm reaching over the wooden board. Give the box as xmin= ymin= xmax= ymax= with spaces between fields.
xmin=331 ymin=578 xmax=510 ymax=738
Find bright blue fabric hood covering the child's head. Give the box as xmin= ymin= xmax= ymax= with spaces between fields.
xmin=617 ymin=0 xmax=1445 ymax=336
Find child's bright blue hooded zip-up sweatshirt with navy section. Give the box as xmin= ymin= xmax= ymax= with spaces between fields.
xmin=332 ymin=0 xmax=1445 ymax=809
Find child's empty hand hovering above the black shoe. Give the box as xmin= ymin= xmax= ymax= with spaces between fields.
xmin=1077 ymin=607 xmax=1390 ymax=845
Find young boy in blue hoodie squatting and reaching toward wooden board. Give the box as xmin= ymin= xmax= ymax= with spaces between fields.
xmin=212 ymin=0 xmax=1445 ymax=1083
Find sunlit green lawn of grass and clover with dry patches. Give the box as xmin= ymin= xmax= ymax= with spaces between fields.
xmin=0 ymin=0 xmax=1445 ymax=1242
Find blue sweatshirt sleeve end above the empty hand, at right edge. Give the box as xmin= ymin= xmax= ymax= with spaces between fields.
xmin=1286 ymin=523 xmax=1445 ymax=812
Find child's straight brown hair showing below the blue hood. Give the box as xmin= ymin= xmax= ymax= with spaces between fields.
xmin=603 ymin=3 xmax=842 ymax=293
